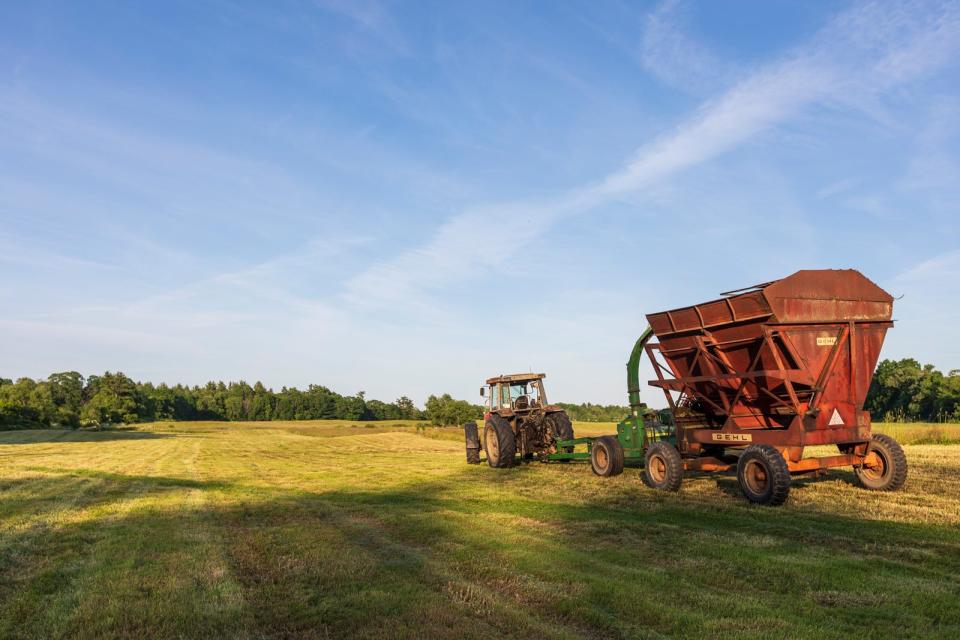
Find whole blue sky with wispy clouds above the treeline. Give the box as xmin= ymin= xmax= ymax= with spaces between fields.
xmin=0 ymin=0 xmax=960 ymax=405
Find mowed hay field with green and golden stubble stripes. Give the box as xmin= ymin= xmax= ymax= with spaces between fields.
xmin=0 ymin=422 xmax=960 ymax=640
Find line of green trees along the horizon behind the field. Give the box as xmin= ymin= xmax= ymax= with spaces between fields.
xmin=0 ymin=358 xmax=960 ymax=429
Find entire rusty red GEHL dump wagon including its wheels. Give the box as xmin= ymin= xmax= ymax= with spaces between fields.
xmin=644 ymin=270 xmax=907 ymax=504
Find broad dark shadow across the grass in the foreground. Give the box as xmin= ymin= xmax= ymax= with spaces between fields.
xmin=0 ymin=467 xmax=960 ymax=640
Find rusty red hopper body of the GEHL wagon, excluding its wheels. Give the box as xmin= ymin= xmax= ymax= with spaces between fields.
xmin=646 ymin=270 xmax=893 ymax=449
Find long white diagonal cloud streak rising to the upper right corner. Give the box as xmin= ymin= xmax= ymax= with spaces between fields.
xmin=345 ymin=2 xmax=960 ymax=306
